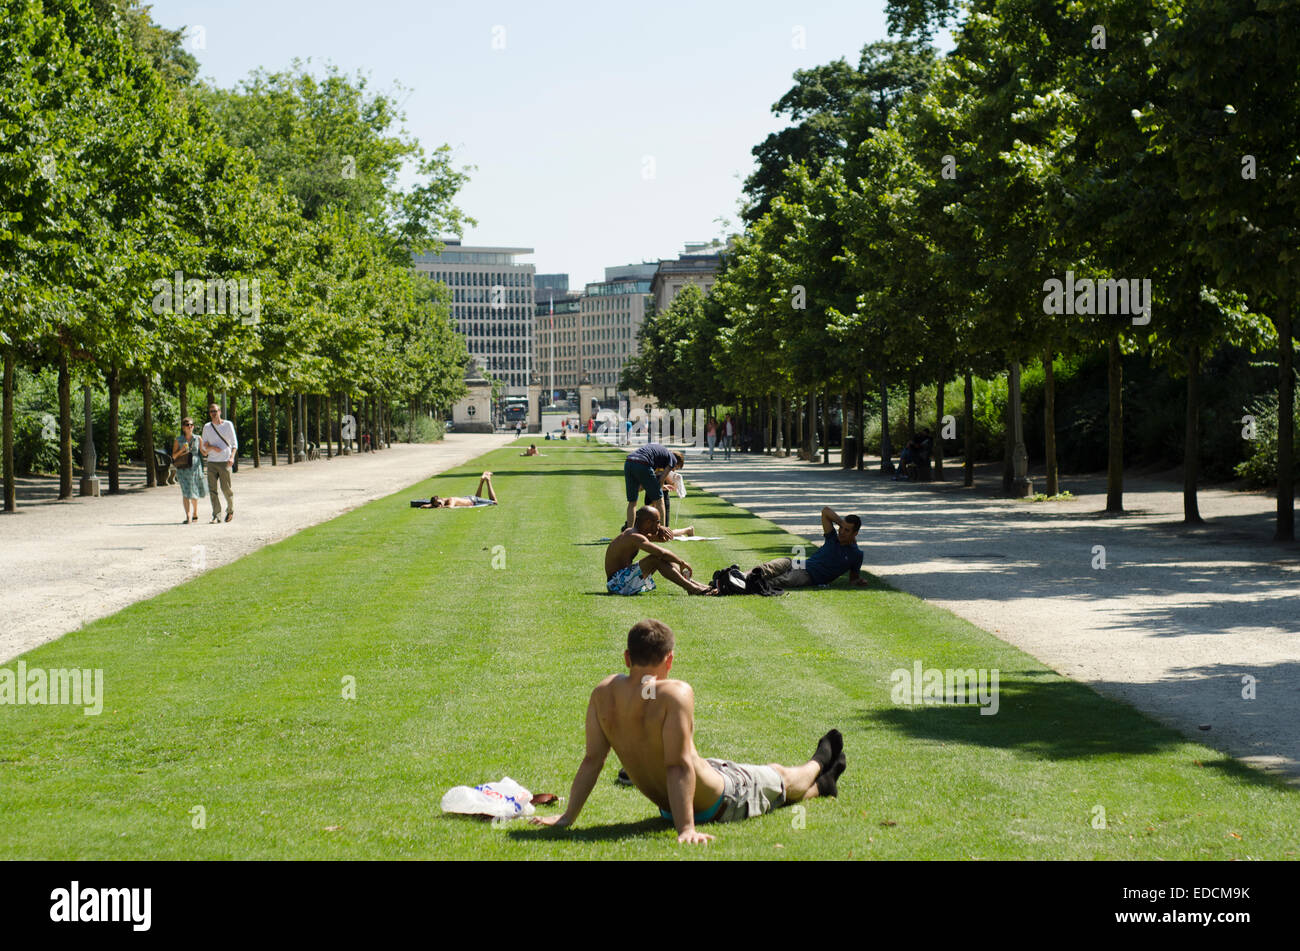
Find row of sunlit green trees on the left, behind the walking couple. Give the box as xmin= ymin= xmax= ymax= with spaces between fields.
xmin=0 ymin=0 xmax=471 ymax=511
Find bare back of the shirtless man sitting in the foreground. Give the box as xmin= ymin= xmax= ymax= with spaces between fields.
xmin=592 ymin=674 xmax=724 ymax=812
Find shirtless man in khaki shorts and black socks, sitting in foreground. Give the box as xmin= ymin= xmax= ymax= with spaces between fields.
xmin=532 ymin=618 xmax=846 ymax=843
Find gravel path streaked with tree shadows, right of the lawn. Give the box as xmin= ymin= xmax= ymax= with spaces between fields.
xmin=685 ymin=452 xmax=1300 ymax=783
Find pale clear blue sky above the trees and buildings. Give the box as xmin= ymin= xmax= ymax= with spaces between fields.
xmin=153 ymin=0 xmax=904 ymax=286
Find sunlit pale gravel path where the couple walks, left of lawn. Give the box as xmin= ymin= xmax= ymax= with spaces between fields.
xmin=0 ymin=434 xmax=515 ymax=664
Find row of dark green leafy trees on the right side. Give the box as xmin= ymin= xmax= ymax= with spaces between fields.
xmin=624 ymin=0 xmax=1300 ymax=540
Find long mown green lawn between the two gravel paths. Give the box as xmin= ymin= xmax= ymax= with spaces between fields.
xmin=0 ymin=443 xmax=1300 ymax=859
